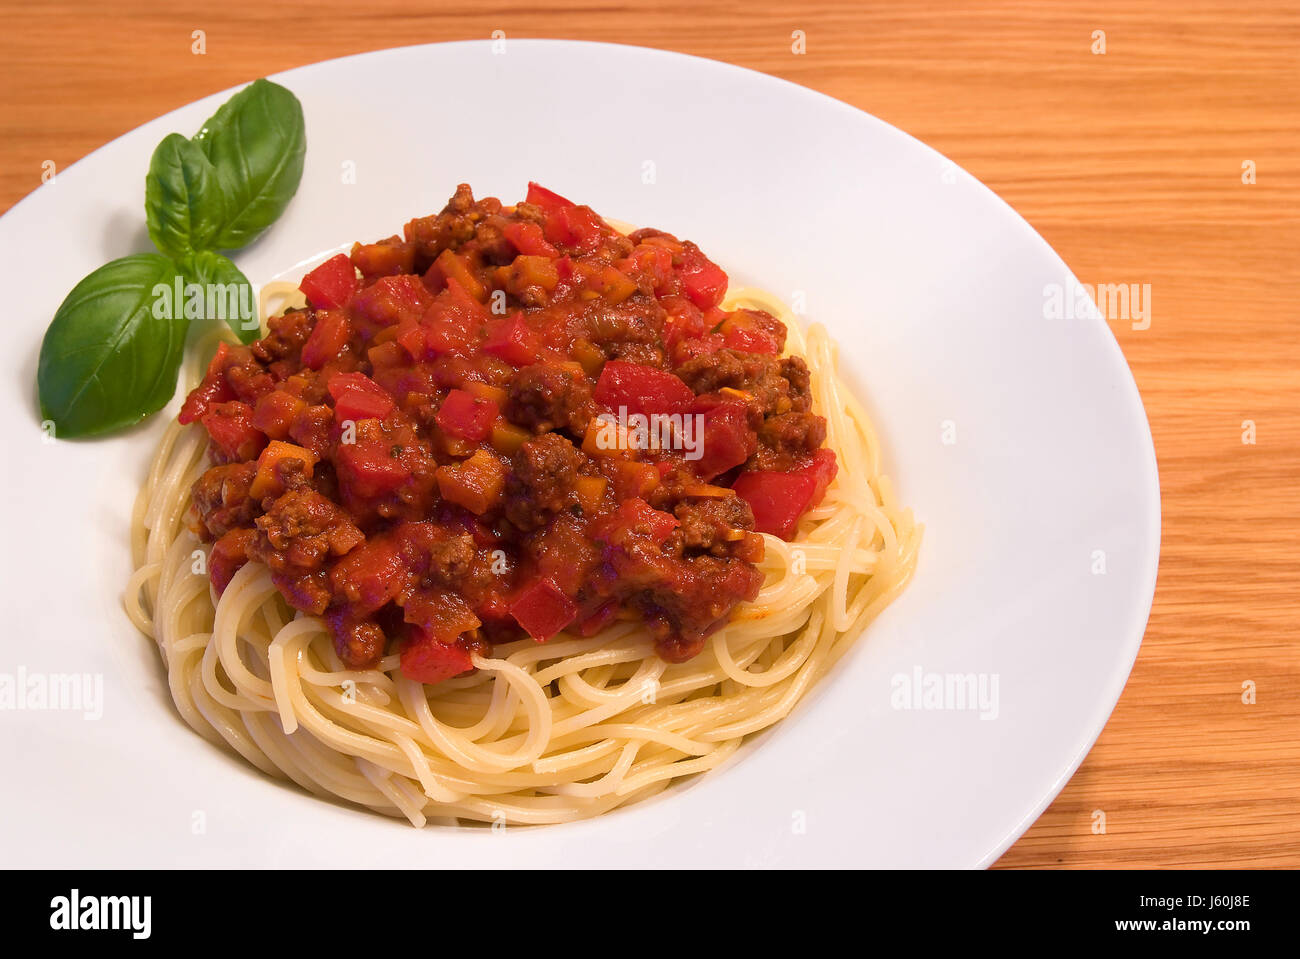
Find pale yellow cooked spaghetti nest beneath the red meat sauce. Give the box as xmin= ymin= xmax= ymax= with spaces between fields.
xmin=125 ymin=230 xmax=920 ymax=826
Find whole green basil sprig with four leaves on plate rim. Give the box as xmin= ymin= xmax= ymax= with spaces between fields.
xmin=36 ymin=79 xmax=307 ymax=437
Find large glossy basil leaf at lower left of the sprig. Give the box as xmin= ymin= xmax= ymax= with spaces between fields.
xmin=36 ymin=253 xmax=187 ymax=437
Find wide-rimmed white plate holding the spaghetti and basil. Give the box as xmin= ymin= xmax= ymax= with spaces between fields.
xmin=0 ymin=40 xmax=1160 ymax=867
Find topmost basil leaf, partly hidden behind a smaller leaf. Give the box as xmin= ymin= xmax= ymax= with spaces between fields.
xmin=194 ymin=79 xmax=307 ymax=249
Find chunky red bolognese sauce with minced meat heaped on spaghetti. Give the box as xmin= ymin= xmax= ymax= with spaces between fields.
xmin=179 ymin=183 xmax=836 ymax=684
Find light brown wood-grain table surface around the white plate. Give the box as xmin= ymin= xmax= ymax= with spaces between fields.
xmin=0 ymin=0 xmax=1300 ymax=867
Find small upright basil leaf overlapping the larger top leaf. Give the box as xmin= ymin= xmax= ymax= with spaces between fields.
xmin=144 ymin=134 xmax=226 ymax=257
